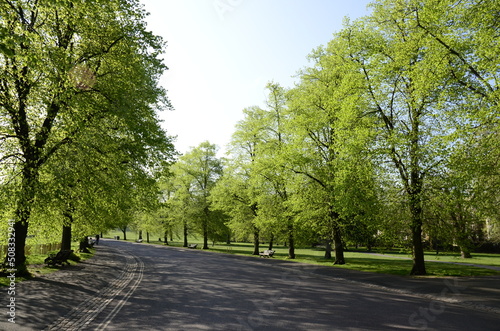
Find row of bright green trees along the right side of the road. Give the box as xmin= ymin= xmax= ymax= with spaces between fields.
xmin=165 ymin=0 xmax=500 ymax=275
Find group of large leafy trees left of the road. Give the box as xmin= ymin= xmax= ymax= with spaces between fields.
xmin=0 ymin=0 xmax=174 ymax=276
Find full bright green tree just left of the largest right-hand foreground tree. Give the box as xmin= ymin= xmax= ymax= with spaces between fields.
xmin=287 ymin=38 xmax=376 ymax=264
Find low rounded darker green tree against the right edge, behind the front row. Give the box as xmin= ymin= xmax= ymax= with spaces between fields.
xmin=428 ymin=126 xmax=499 ymax=258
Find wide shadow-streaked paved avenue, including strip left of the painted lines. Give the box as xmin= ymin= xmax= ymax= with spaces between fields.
xmin=0 ymin=240 xmax=500 ymax=331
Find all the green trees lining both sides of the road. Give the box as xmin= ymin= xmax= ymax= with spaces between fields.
xmin=0 ymin=0 xmax=500 ymax=275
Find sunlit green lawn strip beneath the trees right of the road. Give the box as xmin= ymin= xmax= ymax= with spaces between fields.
xmin=152 ymin=238 xmax=500 ymax=277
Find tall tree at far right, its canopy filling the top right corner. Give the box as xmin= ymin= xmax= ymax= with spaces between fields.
xmin=414 ymin=0 xmax=500 ymax=252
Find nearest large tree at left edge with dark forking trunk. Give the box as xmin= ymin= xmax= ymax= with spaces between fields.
xmin=0 ymin=0 xmax=171 ymax=274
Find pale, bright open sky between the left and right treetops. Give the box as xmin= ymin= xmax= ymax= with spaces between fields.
xmin=141 ymin=0 xmax=369 ymax=153
